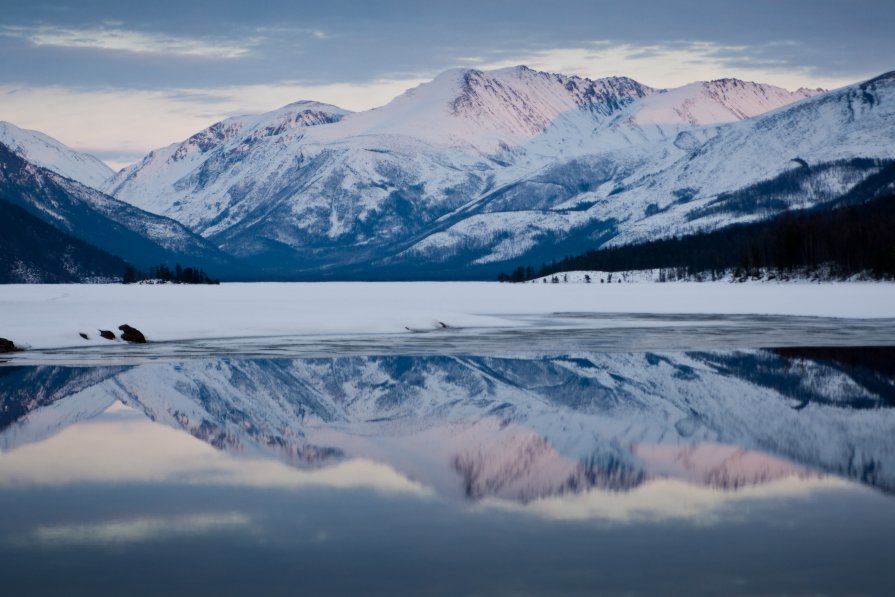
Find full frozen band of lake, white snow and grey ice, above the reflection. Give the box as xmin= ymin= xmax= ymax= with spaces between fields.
xmin=0 ymin=283 xmax=895 ymax=364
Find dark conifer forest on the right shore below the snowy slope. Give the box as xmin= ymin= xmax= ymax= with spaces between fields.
xmin=498 ymin=194 xmax=895 ymax=282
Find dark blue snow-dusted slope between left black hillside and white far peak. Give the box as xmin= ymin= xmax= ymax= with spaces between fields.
xmin=0 ymin=143 xmax=240 ymax=271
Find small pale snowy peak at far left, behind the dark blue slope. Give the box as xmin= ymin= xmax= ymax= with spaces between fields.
xmin=0 ymin=121 xmax=114 ymax=188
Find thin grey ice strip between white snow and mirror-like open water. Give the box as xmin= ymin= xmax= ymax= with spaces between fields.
xmin=4 ymin=313 xmax=895 ymax=365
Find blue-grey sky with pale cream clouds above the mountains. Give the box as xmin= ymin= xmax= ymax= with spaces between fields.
xmin=0 ymin=0 xmax=895 ymax=169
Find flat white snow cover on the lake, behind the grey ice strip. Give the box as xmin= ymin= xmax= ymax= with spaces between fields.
xmin=0 ymin=282 xmax=895 ymax=349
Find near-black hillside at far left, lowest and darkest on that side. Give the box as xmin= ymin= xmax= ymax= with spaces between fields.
xmin=0 ymin=199 xmax=127 ymax=283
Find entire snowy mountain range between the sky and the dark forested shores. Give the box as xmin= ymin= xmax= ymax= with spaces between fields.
xmin=0 ymin=67 xmax=895 ymax=279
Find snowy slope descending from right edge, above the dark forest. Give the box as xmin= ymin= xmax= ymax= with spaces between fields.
xmin=403 ymin=74 xmax=895 ymax=272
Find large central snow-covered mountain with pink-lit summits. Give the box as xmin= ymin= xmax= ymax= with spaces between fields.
xmin=103 ymin=67 xmax=840 ymax=272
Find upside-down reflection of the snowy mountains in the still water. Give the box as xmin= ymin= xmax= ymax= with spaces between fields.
xmin=0 ymin=351 xmax=895 ymax=502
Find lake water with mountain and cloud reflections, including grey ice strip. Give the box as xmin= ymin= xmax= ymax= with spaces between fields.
xmin=0 ymin=313 xmax=895 ymax=595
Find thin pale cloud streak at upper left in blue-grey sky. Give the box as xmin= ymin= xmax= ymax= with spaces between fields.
xmin=0 ymin=25 xmax=259 ymax=59
